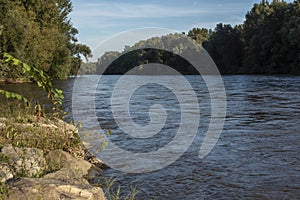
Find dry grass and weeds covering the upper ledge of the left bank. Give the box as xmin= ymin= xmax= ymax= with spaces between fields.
xmin=0 ymin=101 xmax=83 ymax=153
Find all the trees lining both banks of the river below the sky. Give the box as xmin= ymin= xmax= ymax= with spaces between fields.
xmin=0 ymin=0 xmax=300 ymax=80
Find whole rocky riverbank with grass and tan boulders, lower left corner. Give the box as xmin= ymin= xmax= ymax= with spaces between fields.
xmin=0 ymin=116 xmax=106 ymax=200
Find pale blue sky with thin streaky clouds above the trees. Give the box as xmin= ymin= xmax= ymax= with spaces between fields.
xmin=70 ymin=0 xmax=286 ymax=49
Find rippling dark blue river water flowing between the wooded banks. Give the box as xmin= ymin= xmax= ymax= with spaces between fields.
xmin=0 ymin=76 xmax=300 ymax=199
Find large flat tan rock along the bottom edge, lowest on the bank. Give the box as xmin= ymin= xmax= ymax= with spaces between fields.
xmin=9 ymin=178 xmax=106 ymax=200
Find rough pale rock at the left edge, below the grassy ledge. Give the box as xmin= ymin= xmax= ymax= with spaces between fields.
xmin=1 ymin=145 xmax=47 ymax=177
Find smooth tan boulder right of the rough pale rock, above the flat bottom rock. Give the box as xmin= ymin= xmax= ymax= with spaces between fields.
xmin=46 ymin=150 xmax=92 ymax=176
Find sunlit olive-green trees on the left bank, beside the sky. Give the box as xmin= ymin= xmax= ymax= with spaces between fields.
xmin=0 ymin=0 xmax=91 ymax=79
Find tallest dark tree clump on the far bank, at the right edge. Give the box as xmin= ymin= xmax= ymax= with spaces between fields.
xmin=216 ymin=0 xmax=300 ymax=74
